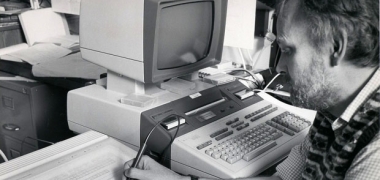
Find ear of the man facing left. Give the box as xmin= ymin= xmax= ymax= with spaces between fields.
xmin=331 ymin=29 xmax=347 ymax=66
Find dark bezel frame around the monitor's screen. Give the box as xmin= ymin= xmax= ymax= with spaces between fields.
xmin=143 ymin=0 xmax=227 ymax=83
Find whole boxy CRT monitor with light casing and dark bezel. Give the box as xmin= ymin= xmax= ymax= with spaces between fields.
xmin=80 ymin=0 xmax=227 ymax=83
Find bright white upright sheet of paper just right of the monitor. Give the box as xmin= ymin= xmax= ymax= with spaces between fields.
xmin=224 ymin=0 xmax=256 ymax=49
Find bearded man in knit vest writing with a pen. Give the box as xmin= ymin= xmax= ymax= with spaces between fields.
xmin=124 ymin=0 xmax=380 ymax=180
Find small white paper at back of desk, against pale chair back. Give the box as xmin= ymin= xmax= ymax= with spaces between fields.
xmin=35 ymin=35 xmax=79 ymax=48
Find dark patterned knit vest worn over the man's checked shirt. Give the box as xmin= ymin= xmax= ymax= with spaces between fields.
xmin=302 ymin=85 xmax=380 ymax=180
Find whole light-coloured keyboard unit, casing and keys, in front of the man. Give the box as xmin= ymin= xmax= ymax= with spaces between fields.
xmin=172 ymin=95 xmax=315 ymax=178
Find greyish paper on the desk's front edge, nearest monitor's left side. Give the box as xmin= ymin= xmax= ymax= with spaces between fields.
xmin=32 ymin=53 xmax=107 ymax=79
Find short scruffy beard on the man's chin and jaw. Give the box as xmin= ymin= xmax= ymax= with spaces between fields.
xmin=289 ymin=55 xmax=340 ymax=111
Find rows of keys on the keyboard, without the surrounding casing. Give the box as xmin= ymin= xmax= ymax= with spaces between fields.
xmin=203 ymin=109 xmax=311 ymax=164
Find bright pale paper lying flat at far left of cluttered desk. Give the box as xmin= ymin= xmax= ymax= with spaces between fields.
xmin=8 ymin=44 xmax=71 ymax=65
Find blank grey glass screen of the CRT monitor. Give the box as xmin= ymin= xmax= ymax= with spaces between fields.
xmin=157 ymin=1 xmax=213 ymax=70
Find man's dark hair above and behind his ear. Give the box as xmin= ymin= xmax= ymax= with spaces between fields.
xmin=278 ymin=0 xmax=379 ymax=67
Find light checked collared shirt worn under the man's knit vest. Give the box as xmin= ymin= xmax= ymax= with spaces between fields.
xmin=276 ymin=69 xmax=380 ymax=180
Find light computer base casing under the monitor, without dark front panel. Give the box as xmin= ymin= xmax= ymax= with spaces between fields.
xmin=67 ymin=71 xmax=212 ymax=150
